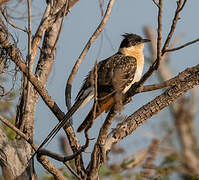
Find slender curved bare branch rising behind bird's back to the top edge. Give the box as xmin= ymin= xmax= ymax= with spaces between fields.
xmin=65 ymin=0 xmax=114 ymax=108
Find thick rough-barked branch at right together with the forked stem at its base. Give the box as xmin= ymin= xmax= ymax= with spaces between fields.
xmin=87 ymin=65 xmax=199 ymax=179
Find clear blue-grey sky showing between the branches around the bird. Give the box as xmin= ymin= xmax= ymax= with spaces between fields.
xmin=3 ymin=0 xmax=199 ymax=177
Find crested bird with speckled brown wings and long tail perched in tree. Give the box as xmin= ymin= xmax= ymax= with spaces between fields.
xmin=32 ymin=33 xmax=150 ymax=157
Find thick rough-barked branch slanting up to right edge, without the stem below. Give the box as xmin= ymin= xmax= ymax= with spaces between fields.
xmin=104 ymin=65 xmax=199 ymax=152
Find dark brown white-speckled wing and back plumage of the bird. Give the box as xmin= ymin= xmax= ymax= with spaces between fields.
xmin=76 ymin=53 xmax=137 ymax=100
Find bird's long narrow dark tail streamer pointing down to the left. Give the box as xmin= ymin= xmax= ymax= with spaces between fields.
xmin=30 ymin=99 xmax=84 ymax=160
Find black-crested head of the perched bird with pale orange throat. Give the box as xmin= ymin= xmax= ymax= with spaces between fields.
xmin=119 ymin=33 xmax=150 ymax=55
